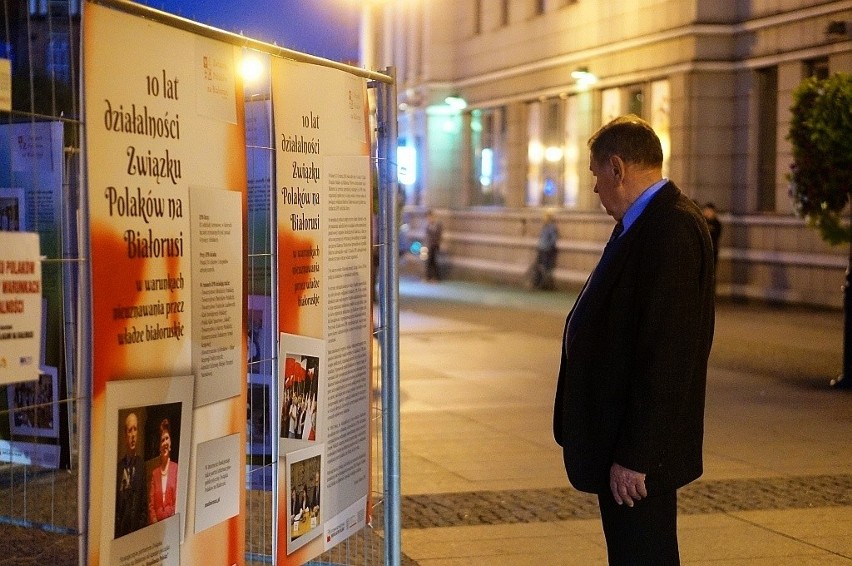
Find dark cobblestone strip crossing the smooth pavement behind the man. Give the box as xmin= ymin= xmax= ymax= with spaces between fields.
xmin=5 ymin=474 xmax=852 ymax=566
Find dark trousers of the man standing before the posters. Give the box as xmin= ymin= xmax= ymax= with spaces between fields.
xmin=598 ymin=491 xmax=680 ymax=566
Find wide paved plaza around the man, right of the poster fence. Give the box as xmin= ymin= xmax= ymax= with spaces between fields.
xmin=392 ymin=279 xmax=852 ymax=566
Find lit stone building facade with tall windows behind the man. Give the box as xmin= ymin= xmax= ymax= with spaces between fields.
xmin=362 ymin=0 xmax=852 ymax=306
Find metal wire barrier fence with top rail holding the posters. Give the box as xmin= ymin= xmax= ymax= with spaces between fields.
xmin=0 ymin=0 xmax=401 ymax=566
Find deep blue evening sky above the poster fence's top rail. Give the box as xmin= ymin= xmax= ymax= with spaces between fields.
xmin=137 ymin=0 xmax=361 ymax=62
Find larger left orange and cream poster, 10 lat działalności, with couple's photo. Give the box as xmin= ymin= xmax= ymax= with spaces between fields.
xmin=82 ymin=3 xmax=246 ymax=566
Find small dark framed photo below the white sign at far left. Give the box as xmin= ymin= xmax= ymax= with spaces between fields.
xmin=6 ymin=367 xmax=59 ymax=438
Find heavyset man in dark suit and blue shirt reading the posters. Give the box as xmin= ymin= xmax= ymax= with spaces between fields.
xmin=553 ymin=115 xmax=715 ymax=566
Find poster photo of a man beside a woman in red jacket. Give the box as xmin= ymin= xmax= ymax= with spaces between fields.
xmin=101 ymin=376 xmax=194 ymax=564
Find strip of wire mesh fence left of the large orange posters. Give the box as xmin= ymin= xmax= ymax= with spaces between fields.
xmin=0 ymin=0 xmax=85 ymax=565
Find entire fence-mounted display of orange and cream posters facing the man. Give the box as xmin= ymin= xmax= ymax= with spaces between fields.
xmin=0 ymin=0 xmax=399 ymax=566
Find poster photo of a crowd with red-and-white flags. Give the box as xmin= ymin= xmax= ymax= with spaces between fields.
xmin=279 ymin=334 xmax=325 ymax=453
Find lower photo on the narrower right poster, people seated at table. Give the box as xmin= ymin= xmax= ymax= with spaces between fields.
xmin=282 ymin=445 xmax=326 ymax=554
